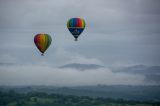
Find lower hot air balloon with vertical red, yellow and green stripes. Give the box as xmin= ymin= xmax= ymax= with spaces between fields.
xmin=34 ymin=33 xmax=52 ymax=56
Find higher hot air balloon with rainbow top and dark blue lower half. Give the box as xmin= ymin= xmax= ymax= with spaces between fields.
xmin=67 ymin=18 xmax=85 ymax=41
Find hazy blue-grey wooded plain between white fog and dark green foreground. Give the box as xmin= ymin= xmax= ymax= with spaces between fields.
xmin=0 ymin=85 xmax=160 ymax=101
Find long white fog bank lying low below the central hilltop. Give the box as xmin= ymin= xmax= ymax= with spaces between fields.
xmin=0 ymin=65 xmax=144 ymax=86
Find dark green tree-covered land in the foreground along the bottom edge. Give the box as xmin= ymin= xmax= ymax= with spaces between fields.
xmin=0 ymin=90 xmax=160 ymax=106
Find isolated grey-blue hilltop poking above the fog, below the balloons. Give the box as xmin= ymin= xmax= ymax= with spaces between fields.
xmin=59 ymin=63 xmax=104 ymax=71
